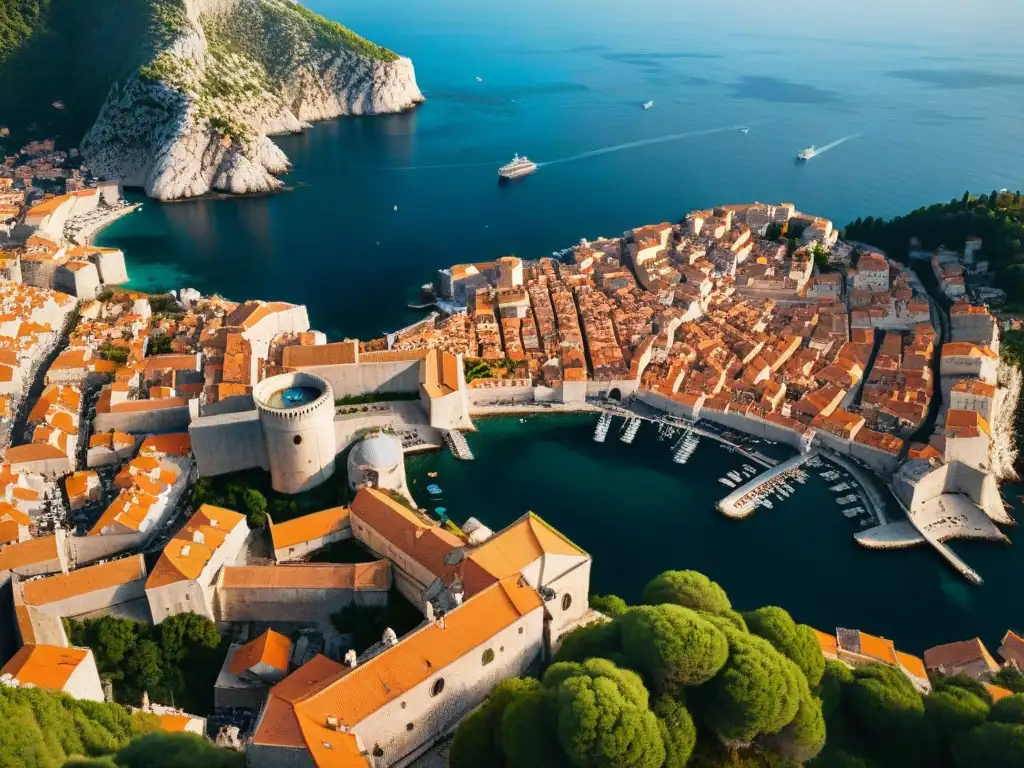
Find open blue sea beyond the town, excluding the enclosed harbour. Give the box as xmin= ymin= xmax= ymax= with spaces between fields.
xmin=100 ymin=0 xmax=1024 ymax=338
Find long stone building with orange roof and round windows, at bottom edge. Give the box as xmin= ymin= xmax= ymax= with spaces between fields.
xmin=246 ymin=578 xmax=545 ymax=768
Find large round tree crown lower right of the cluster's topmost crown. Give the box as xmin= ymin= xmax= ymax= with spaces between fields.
xmin=696 ymin=632 xmax=808 ymax=741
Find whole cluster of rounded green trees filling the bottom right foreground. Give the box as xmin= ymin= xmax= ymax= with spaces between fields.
xmin=450 ymin=571 xmax=1024 ymax=768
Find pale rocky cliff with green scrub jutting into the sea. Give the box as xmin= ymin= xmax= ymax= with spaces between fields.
xmin=81 ymin=0 xmax=423 ymax=200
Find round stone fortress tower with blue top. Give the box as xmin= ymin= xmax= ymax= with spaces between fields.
xmin=253 ymin=372 xmax=335 ymax=494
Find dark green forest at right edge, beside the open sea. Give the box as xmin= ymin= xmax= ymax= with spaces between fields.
xmin=844 ymin=190 xmax=1024 ymax=311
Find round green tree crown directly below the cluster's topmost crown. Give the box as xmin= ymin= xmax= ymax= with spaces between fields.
xmin=618 ymin=604 xmax=729 ymax=693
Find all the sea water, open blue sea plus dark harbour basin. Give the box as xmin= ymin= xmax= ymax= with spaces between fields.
xmin=90 ymin=0 xmax=1024 ymax=652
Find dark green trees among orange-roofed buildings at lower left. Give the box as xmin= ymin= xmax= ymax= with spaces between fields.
xmin=65 ymin=613 xmax=226 ymax=715
